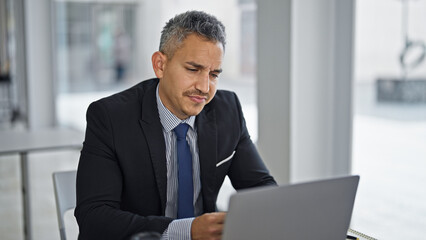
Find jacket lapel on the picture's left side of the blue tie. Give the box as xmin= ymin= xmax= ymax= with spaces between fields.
xmin=140 ymin=84 xmax=167 ymax=214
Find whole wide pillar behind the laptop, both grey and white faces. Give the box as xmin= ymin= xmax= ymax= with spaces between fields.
xmin=258 ymin=0 xmax=354 ymax=183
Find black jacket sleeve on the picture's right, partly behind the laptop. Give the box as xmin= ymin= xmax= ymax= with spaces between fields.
xmin=228 ymin=94 xmax=277 ymax=190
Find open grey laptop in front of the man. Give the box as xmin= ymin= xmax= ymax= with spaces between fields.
xmin=222 ymin=176 xmax=359 ymax=240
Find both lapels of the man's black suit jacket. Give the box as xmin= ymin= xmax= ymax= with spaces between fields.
xmin=139 ymin=80 xmax=217 ymax=214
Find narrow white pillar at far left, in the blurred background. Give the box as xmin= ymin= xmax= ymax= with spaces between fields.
xmin=24 ymin=0 xmax=55 ymax=128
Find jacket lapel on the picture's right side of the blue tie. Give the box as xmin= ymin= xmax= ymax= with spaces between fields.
xmin=197 ymin=106 xmax=217 ymax=212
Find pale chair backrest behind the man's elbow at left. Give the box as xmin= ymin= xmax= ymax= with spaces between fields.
xmin=53 ymin=171 xmax=77 ymax=240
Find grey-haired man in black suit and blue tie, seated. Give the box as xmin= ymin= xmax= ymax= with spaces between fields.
xmin=75 ymin=11 xmax=276 ymax=239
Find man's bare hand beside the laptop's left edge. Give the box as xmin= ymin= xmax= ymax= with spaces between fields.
xmin=191 ymin=212 xmax=226 ymax=240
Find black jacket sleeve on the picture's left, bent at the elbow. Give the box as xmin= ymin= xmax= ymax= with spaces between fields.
xmin=74 ymin=101 xmax=172 ymax=239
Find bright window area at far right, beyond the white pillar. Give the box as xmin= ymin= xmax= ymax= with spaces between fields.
xmin=352 ymin=0 xmax=426 ymax=239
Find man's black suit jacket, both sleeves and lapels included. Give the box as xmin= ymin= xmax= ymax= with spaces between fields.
xmin=75 ymin=79 xmax=276 ymax=239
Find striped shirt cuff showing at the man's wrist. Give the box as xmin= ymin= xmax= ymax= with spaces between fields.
xmin=161 ymin=218 xmax=194 ymax=240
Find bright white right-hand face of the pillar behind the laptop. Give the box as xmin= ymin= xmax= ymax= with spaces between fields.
xmin=291 ymin=0 xmax=354 ymax=181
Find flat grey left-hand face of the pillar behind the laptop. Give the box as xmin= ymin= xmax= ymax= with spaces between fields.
xmin=257 ymin=0 xmax=292 ymax=183
